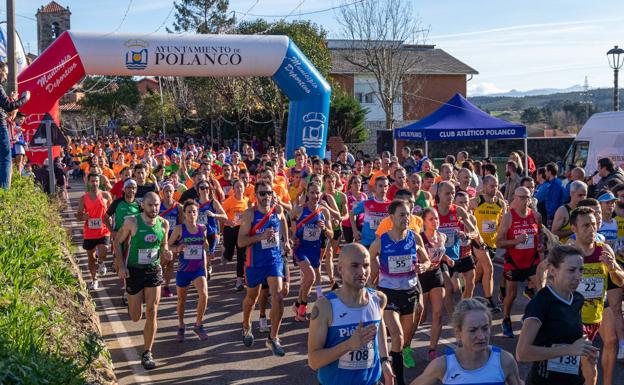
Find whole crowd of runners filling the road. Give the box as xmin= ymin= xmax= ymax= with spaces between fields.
xmin=48 ymin=137 xmax=624 ymax=385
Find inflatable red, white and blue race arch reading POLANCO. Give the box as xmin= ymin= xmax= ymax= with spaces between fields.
xmin=18 ymin=31 xmax=331 ymax=158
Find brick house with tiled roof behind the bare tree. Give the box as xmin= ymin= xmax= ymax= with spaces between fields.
xmin=327 ymin=40 xmax=478 ymax=152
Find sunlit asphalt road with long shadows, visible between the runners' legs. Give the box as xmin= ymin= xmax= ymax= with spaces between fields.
xmin=63 ymin=182 xmax=624 ymax=385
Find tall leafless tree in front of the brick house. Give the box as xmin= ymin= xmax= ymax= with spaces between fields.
xmin=338 ymin=0 xmax=428 ymax=130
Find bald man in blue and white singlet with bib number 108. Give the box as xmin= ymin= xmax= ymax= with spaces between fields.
xmin=308 ymin=243 xmax=394 ymax=385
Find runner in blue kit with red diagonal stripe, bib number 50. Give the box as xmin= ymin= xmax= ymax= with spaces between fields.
xmin=292 ymin=183 xmax=334 ymax=322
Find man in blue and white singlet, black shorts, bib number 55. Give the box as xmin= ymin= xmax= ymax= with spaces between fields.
xmin=370 ymin=199 xmax=430 ymax=385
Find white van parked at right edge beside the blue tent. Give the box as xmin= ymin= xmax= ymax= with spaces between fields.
xmin=563 ymin=112 xmax=624 ymax=176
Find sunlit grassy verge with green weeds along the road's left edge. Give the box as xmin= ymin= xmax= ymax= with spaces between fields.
xmin=0 ymin=176 xmax=107 ymax=385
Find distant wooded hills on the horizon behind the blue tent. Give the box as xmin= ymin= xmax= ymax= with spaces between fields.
xmin=468 ymin=88 xmax=624 ymax=112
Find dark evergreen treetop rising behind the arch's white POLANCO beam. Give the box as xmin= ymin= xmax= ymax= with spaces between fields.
xmin=167 ymin=0 xmax=235 ymax=34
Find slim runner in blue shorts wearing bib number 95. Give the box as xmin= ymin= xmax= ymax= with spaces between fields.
xmin=169 ymin=200 xmax=208 ymax=342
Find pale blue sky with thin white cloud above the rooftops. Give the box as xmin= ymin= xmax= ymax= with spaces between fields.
xmin=8 ymin=0 xmax=624 ymax=96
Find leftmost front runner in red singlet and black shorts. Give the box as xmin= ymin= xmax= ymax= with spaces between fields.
xmin=76 ymin=173 xmax=113 ymax=290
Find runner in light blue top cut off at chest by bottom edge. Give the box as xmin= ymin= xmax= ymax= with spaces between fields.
xmin=412 ymin=298 xmax=522 ymax=385
